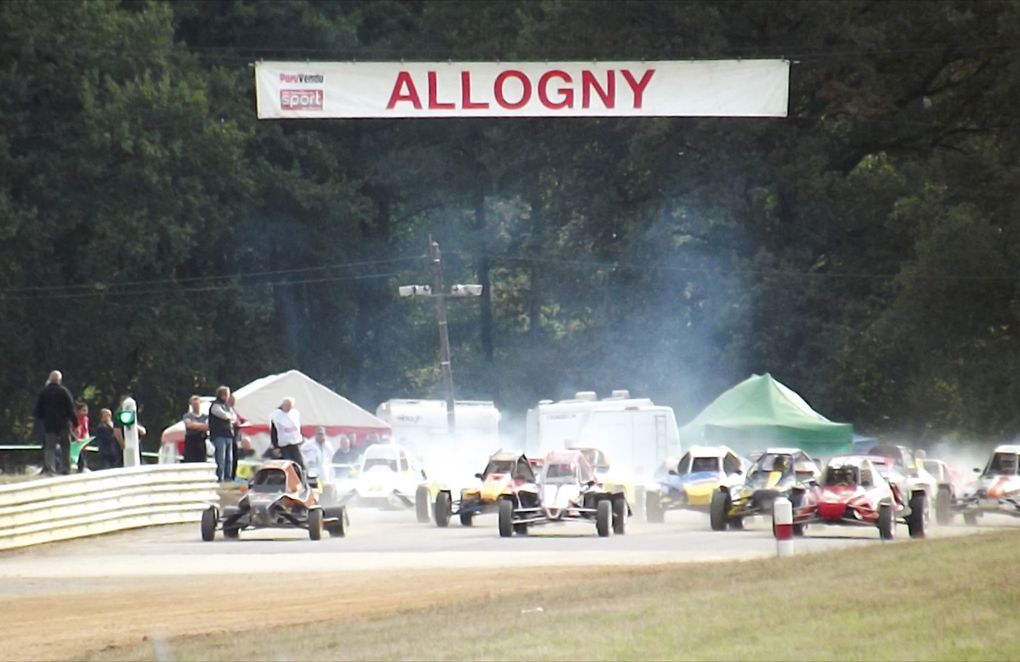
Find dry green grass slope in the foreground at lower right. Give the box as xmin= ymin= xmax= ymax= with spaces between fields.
xmin=83 ymin=532 xmax=1020 ymax=660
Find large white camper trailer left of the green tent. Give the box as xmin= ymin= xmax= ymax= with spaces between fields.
xmin=526 ymin=391 xmax=680 ymax=481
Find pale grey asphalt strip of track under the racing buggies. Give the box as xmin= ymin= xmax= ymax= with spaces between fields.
xmin=0 ymin=508 xmax=1003 ymax=597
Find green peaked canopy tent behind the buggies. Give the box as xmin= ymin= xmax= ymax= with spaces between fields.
xmin=680 ymin=372 xmax=854 ymax=457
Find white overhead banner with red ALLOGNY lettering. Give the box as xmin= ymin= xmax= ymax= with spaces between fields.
xmin=255 ymin=60 xmax=789 ymax=119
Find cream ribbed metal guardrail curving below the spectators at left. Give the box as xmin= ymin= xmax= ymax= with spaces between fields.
xmin=0 ymin=464 xmax=218 ymax=550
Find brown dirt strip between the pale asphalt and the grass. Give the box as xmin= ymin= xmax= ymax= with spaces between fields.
xmin=0 ymin=567 xmax=652 ymax=660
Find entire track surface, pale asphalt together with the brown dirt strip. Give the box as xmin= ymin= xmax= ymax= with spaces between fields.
xmin=0 ymin=509 xmax=1020 ymax=662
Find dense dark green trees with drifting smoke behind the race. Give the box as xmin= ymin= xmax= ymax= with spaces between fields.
xmin=0 ymin=0 xmax=1020 ymax=448
